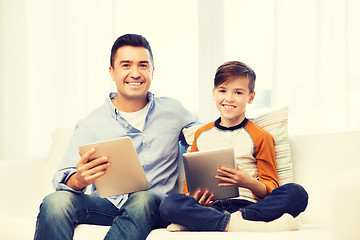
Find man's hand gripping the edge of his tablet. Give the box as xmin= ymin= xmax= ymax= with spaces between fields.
xmin=66 ymin=148 xmax=110 ymax=190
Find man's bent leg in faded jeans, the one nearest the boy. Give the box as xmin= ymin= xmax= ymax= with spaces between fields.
xmin=105 ymin=191 xmax=165 ymax=240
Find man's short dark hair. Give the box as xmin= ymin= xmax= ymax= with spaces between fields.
xmin=110 ymin=34 xmax=154 ymax=67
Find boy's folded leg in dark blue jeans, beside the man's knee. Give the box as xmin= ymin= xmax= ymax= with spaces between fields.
xmin=160 ymin=194 xmax=230 ymax=231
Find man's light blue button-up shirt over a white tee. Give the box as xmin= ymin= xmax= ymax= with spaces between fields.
xmin=53 ymin=92 xmax=197 ymax=208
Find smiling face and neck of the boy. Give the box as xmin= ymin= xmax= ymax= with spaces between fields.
xmin=213 ymin=77 xmax=255 ymax=127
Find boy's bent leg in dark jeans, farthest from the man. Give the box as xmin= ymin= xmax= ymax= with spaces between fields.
xmin=240 ymin=183 xmax=308 ymax=222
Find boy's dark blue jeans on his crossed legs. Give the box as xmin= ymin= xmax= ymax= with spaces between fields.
xmin=160 ymin=183 xmax=308 ymax=231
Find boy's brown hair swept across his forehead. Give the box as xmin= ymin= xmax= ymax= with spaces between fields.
xmin=214 ymin=61 xmax=256 ymax=93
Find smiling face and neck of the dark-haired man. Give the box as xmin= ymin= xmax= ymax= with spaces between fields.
xmin=109 ymin=46 xmax=154 ymax=101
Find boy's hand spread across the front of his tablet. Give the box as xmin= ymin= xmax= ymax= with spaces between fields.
xmin=215 ymin=167 xmax=255 ymax=188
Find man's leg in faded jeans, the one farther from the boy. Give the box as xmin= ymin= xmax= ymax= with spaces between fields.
xmin=34 ymin=191 xmax=118 ymax=240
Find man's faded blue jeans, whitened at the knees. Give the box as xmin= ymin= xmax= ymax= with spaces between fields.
xmin=34 ymin=191 xmax=163 ymax=240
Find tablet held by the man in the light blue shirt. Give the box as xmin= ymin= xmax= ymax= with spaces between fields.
xmin=79 ymin=137 xmax=149 ymax=197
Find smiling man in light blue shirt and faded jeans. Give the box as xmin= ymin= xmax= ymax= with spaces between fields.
xmin=35 ymin=34 xmax=196 ymax=240
